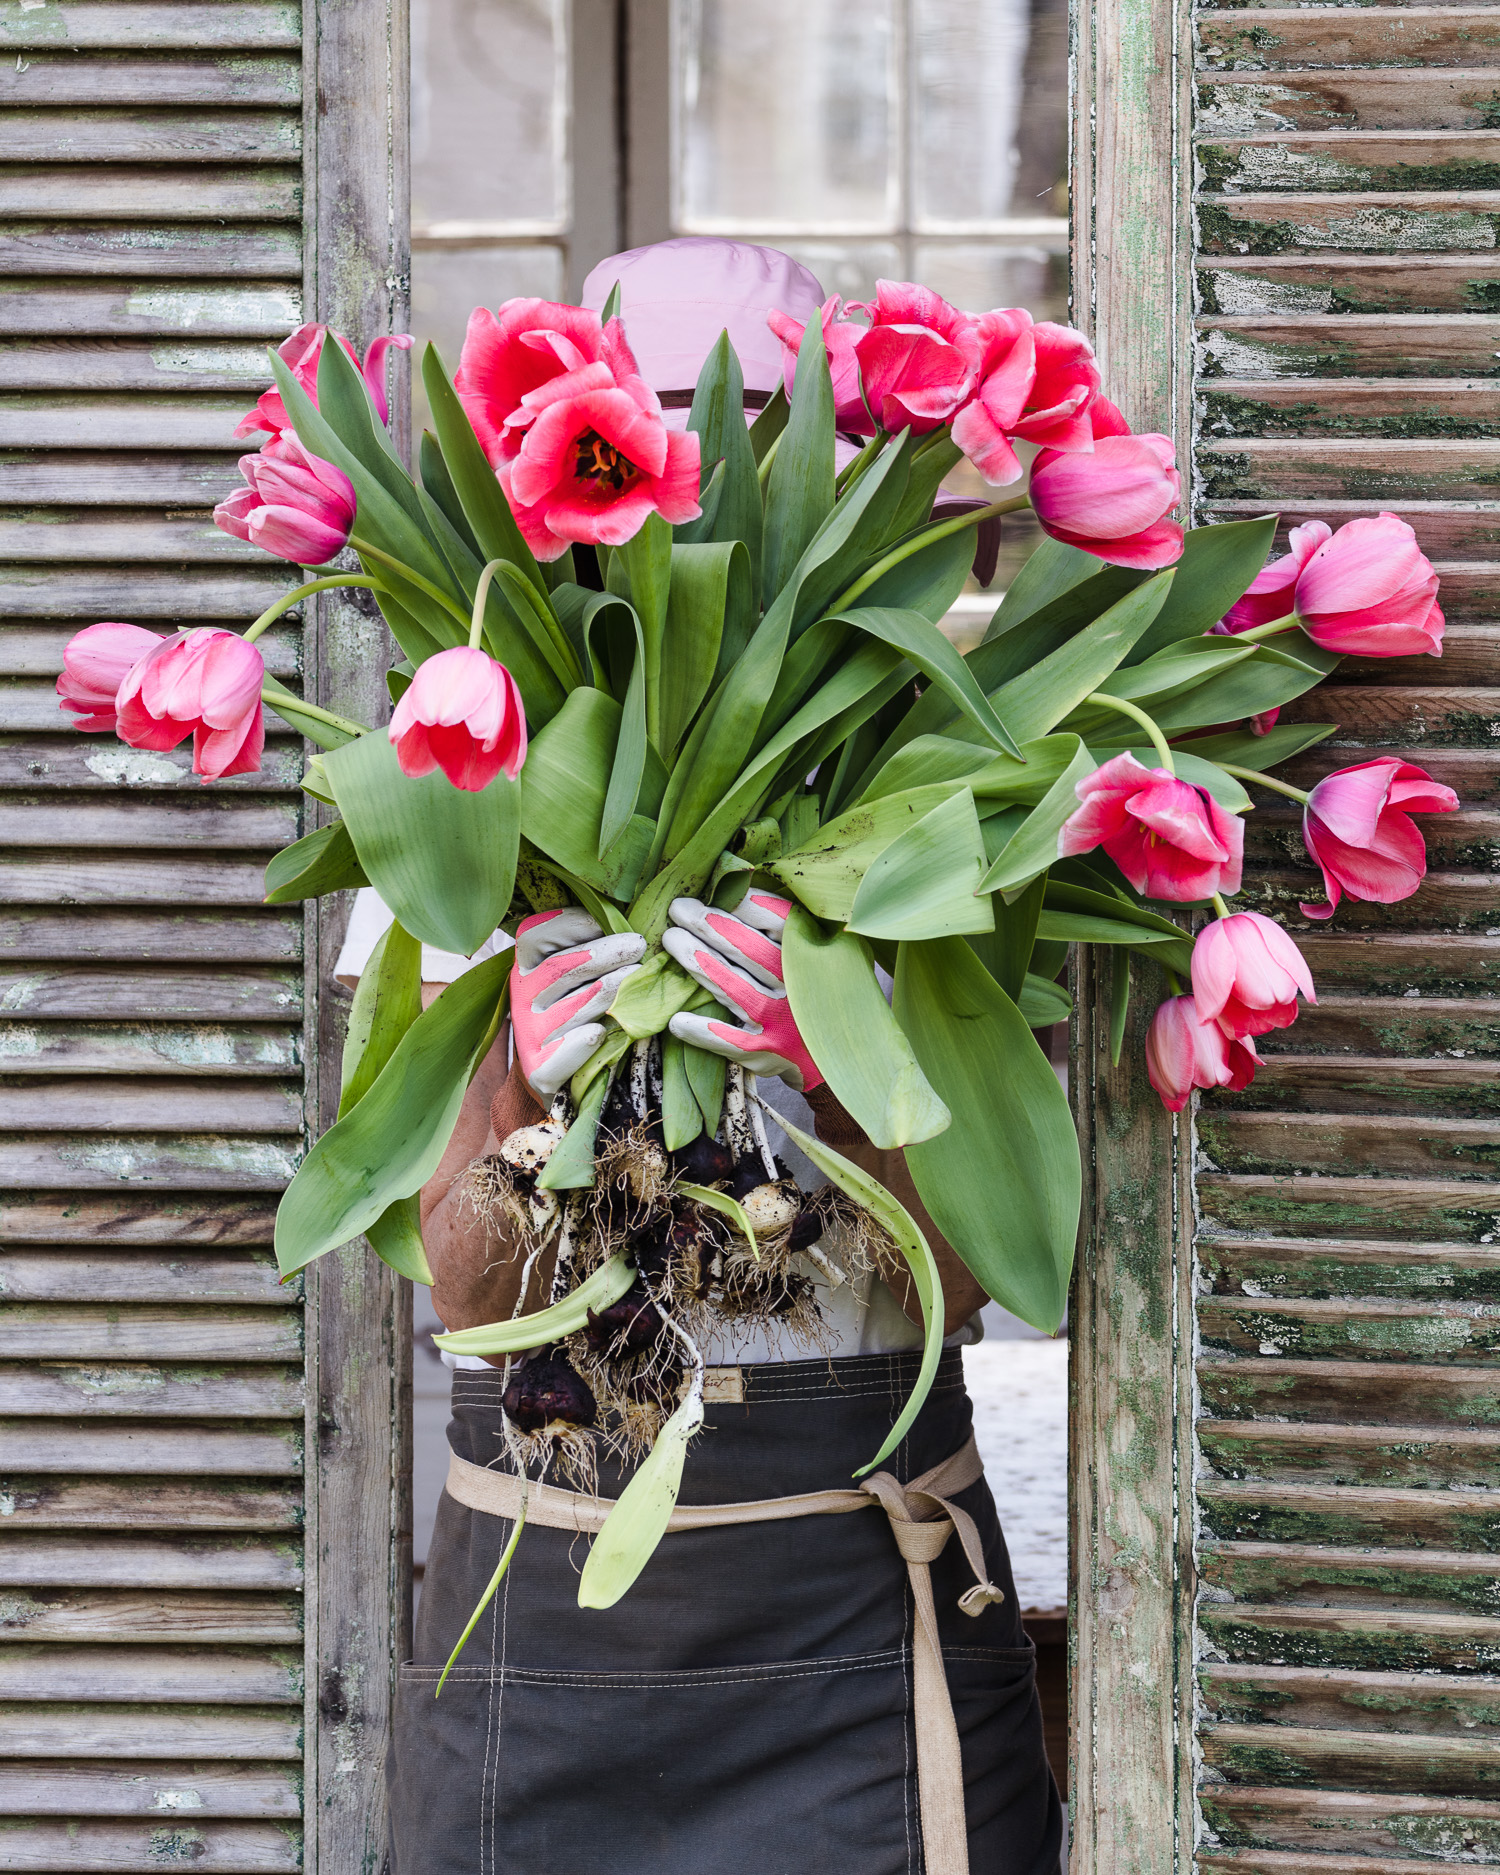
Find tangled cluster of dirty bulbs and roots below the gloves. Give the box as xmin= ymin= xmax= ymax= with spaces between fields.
xmin=463 ymin=1069 xmax=896 ymax=1491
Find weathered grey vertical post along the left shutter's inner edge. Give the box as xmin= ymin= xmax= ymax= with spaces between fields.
xmin=302 ymin=0 xmax=411 ymax=1875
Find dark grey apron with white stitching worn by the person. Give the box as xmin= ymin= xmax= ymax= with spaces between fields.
xmin=390 ymin=1350 xmax=1061 ymax=1875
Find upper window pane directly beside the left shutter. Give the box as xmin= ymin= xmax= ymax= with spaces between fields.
xmin=411 ymin=0 xmax=568 ymax=231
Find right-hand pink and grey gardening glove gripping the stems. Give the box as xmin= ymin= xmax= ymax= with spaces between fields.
xmin=662 ymin=891 xmax=823 ymax=1093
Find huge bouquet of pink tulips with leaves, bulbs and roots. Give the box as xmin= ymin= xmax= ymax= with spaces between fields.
xmin=60 ymin=283 xmax=1457 ymax=1605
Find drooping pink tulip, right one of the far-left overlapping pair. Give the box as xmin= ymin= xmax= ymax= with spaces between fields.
xmin=116 ymin=628 xmax=266 ymax=780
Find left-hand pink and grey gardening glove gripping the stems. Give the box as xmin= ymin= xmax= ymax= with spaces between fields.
xmin=510 ymin=906 xmax=645 ymax=1106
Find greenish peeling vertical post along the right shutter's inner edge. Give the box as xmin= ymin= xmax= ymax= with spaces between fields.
xmin=1069 ymin=0 xmax=1194 ymax=1875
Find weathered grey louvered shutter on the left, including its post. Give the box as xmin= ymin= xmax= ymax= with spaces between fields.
xmin=0 ymin=0 xmax=405 ymax=1871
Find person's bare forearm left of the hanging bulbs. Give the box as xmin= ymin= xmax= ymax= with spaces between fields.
xmin=420 ymin=1031 xmax=551 ymax=1329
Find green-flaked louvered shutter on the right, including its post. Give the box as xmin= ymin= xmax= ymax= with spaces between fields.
xmin=1074 ymin=0 xmax=1500 ymax=1875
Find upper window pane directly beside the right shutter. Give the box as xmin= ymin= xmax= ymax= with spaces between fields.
xmin=911 ymin=0 xmax=1067 ymax=229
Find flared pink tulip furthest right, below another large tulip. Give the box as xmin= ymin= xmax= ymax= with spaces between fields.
xmin=1301 ymin=761 xmax=1459 ymax=919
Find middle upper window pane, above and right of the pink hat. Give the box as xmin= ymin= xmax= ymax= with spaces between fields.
xmin=673 ymin=0 xmax=898 ymax=233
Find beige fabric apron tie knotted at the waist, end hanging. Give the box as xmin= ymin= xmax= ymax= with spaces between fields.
xmin=448 ymin=1434 xmax=1005 ymax=1875
